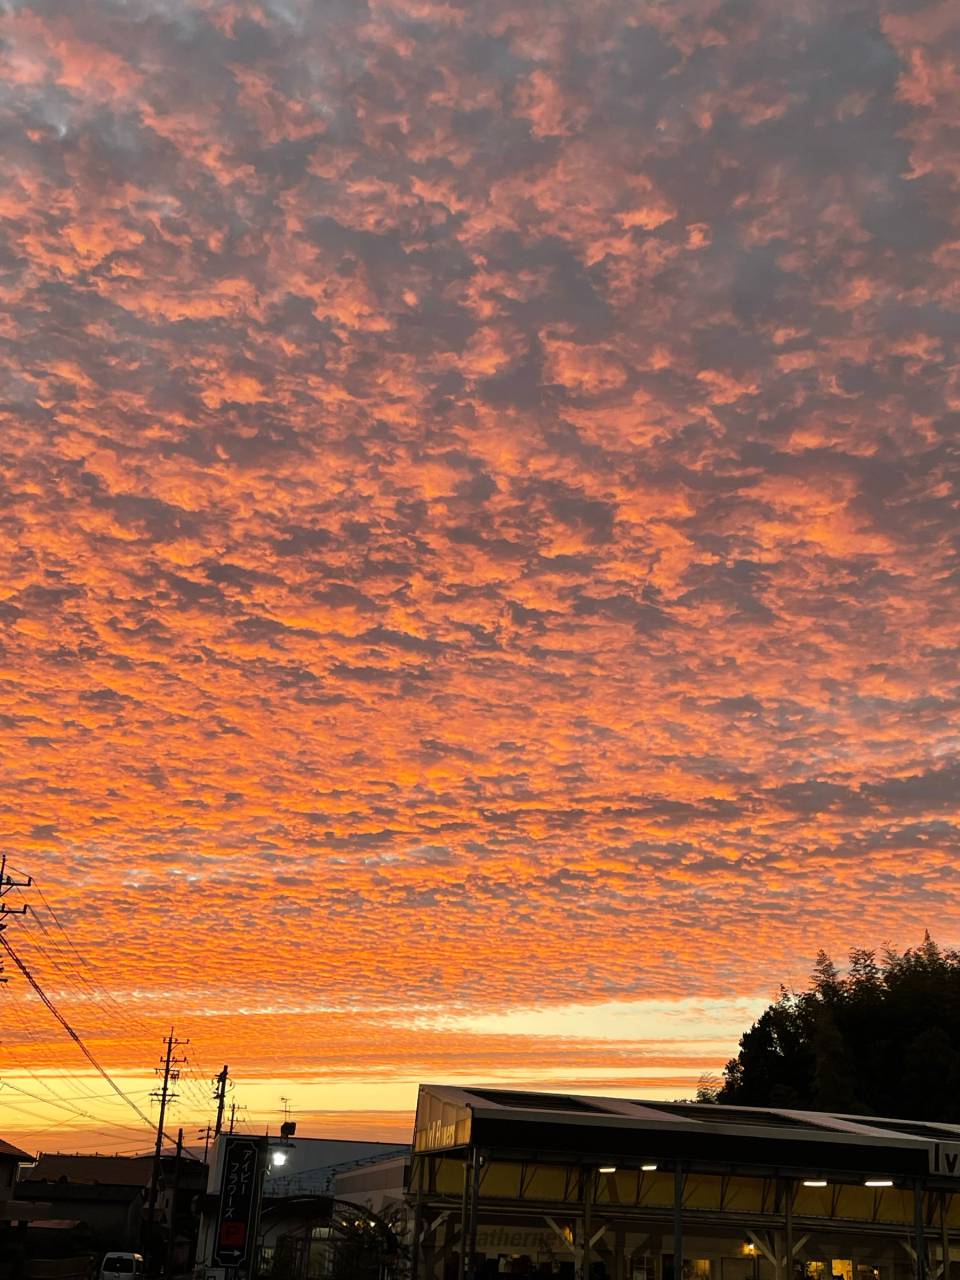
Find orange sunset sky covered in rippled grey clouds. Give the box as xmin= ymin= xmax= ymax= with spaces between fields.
xmin=0 ymin=0 xmax=960 ymax=1149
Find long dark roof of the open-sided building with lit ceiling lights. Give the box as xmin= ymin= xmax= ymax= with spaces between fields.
xmin=415 ymin=1084 xmax=960 ymax=1176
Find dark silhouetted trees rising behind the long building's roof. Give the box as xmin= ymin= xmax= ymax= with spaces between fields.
xmin=716 ymin=934 xmax=960 ymax=1123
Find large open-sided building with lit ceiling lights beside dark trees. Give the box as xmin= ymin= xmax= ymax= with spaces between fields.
xmin=408 ymin=1085 xmax=960 ymax=1280
